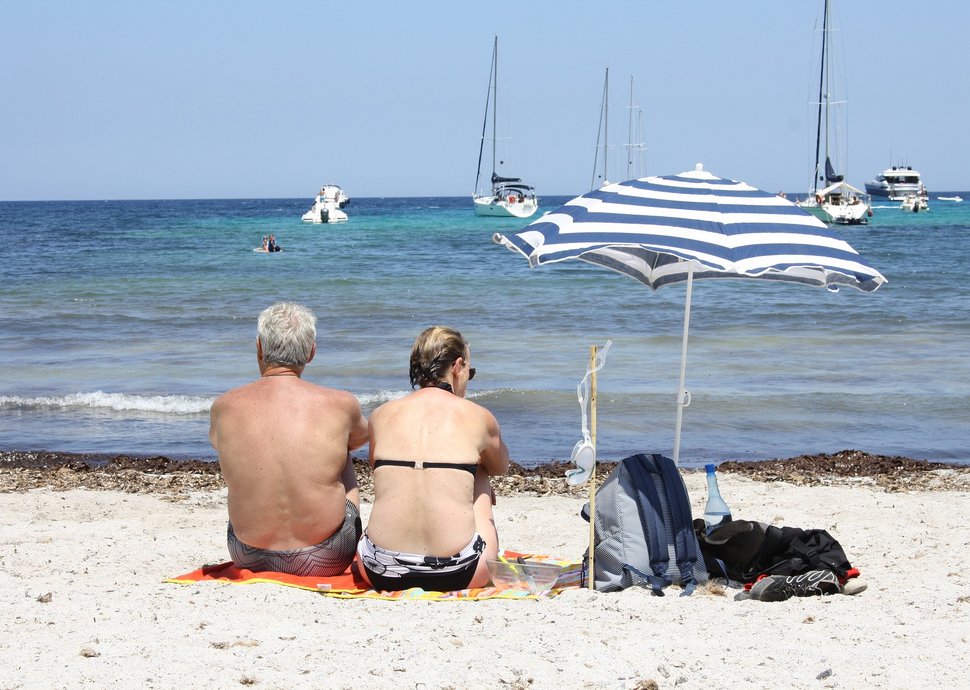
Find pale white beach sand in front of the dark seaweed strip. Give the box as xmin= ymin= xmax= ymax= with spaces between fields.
xmin=0 ymin=474 xmax=970 ymax=690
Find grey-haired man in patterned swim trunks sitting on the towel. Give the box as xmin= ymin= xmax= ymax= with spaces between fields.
xmin=209 ymin=302 xmax=368 ymax=576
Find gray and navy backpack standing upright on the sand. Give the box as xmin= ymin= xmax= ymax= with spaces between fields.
xmin=582 ymin=453 xmax=707 ymax=596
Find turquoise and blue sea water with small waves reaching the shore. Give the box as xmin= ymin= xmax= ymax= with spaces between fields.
xmin=0 ymin=193 xmax=970 ymax=466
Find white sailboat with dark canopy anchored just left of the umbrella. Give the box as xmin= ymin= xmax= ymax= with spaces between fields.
xmin=472 ymin=36 xmax=539 ymax=218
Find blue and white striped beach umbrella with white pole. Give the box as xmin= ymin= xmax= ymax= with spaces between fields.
xmin=493 ymin=164 xmax=886 ymax=463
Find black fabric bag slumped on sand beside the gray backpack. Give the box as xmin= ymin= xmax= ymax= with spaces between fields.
xmin=694 ymin=520 xmax=852 ymax=582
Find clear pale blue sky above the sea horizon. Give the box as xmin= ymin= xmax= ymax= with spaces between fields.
xmin=0 ymin=0 xmax=970 ymax=200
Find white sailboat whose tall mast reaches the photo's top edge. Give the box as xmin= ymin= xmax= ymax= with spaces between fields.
xmin=799 ymin=0 xmax=872 ymax=225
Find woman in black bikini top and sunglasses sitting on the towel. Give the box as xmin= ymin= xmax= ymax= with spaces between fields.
xmin=357 ymin=326 xmax=509 ymax=591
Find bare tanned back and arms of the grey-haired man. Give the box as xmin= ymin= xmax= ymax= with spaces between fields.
xmin=209 ymin=305 xmax=368 ymax=564
